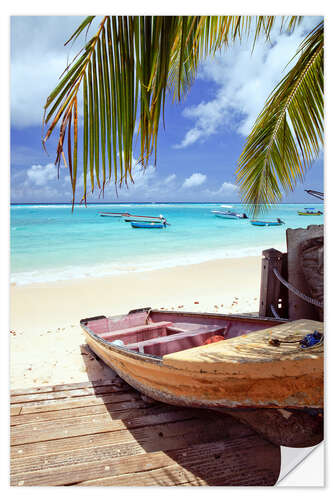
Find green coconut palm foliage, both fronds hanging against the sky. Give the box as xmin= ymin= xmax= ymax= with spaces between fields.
xmin=43 ymin=16 xmax=323 ymax=210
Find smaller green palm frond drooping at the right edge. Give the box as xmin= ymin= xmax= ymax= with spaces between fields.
xmin=237 ymin=22 xmax=324 ymax=214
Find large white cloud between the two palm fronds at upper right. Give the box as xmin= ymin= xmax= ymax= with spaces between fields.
xmin=174 ymin=16 xmax=319 ymax=148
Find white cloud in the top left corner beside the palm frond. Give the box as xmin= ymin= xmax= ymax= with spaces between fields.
xmin=10 ymin=16 xmax=98 ymax=128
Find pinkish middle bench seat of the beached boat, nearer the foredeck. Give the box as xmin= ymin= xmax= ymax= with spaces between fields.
xmin=126 ymin=325 xmax=226 ymax=356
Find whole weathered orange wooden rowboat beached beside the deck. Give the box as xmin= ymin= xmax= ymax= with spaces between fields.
xmin=80 ymin=309 xmax=323 ymax=409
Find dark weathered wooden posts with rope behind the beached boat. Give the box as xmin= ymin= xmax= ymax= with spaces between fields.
xmin=259 ymin=225 xmax=324 ymax=321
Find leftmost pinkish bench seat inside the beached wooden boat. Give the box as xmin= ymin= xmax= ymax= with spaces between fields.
xmin=98 ymin=321 xmax=172 ymax=344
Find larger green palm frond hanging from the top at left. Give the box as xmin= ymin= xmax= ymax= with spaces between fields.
xmin=43 ymin=16 xmax=301 ymax=207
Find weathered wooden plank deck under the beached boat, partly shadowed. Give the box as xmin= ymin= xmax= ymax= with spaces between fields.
xmin=11 ymin=375 xmax=280 ymax=486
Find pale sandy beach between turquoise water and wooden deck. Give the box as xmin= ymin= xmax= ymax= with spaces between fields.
xmin=10 ymin=257 xmax=261 ymax=389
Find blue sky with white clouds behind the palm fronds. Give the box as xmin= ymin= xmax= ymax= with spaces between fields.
xmin=10 ymin=16 xmax=323 ymax=203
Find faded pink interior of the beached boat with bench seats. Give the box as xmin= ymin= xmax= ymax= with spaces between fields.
xmin=81 ymin=310 xmax=281 ymax=357
